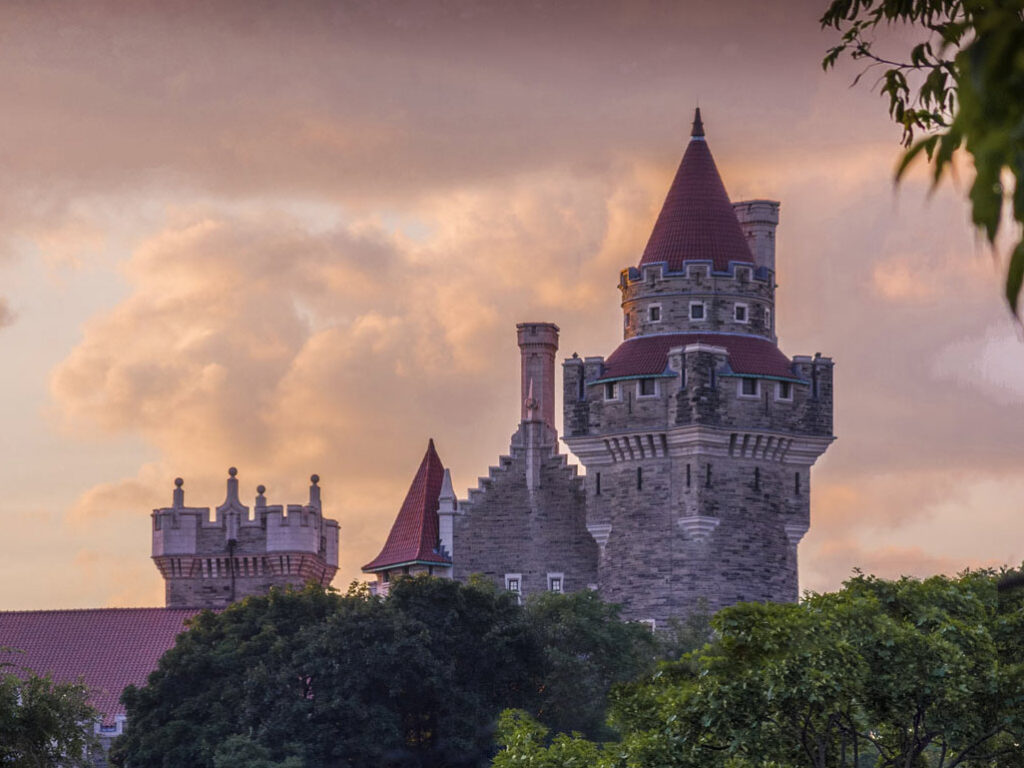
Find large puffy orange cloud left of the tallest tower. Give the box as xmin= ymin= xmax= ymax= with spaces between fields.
xmin=51 ymin=160 xmax=663 ymax=581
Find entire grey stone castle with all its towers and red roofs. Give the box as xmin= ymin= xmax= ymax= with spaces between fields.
xmin=0 ymin=110 xmax=834 ymax=739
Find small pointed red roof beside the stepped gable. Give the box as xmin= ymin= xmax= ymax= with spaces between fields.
xmin=362 ymin=440 xmax=452 ymax=571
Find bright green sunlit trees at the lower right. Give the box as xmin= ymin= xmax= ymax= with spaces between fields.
xmin=496 ymin=571 xmax=1024 ymax=768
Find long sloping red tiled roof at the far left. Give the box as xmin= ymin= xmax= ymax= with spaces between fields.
xmin=0 ymin=608 xmax=199 ymax=725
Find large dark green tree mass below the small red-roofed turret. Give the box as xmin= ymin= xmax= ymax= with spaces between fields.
xmin=112 ymin=578 xmax=541 ymax=768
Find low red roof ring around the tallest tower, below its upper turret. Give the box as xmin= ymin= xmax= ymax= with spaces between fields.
xmin=602 ymin=333 xmax=796 ymax=379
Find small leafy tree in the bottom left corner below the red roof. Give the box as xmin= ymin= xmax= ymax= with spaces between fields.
xmin=0 ymin=674 xmax=96 ymax=768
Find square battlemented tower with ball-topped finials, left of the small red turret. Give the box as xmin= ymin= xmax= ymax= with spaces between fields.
xmin=153 ymin=467 xmax=338 ymax=608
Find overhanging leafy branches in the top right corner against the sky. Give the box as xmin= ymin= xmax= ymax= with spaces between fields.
xmin=820 ymin=0 xmax=1024 ymax=312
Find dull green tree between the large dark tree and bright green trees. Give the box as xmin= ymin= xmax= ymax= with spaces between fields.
xmin=526 ymin=590 xmax=658 ymax=740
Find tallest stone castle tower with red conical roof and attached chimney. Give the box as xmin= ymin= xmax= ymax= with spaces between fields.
xmin=563 ymin=110 xmax=834 ymax=625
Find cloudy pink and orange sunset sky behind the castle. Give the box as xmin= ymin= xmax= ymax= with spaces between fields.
xmin=0 ymin=0 xmax=1024 ymax=609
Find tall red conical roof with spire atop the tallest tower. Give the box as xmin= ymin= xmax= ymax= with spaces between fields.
xmin=640 ymin=108 xmax=754 ymax=271
